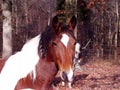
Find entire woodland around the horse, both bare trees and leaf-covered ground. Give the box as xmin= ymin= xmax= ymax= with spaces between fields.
xmin=0 ymin=0 xmax=120 ymax=90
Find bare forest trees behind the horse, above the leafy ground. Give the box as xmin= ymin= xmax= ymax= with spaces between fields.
xmin=0 ymin=0 xmax=120 ymax=63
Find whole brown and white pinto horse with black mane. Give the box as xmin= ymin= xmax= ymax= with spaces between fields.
xmin=0 ymin=16 xmax=77 ymax=90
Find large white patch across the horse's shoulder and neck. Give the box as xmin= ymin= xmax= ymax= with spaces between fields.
xmin=0 ymin=35 xmax=40 ymax=90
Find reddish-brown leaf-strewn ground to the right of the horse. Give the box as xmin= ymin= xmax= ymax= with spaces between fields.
xmin=57 ymin=60 xmax=120 ymax=90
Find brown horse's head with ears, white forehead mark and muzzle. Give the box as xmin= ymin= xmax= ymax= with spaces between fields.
xmin=50 ymin=16 xmax=77 ymax=87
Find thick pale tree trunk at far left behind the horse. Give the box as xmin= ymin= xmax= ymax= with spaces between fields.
xmin=2 ymin=0 xmax=12 ymax=58
